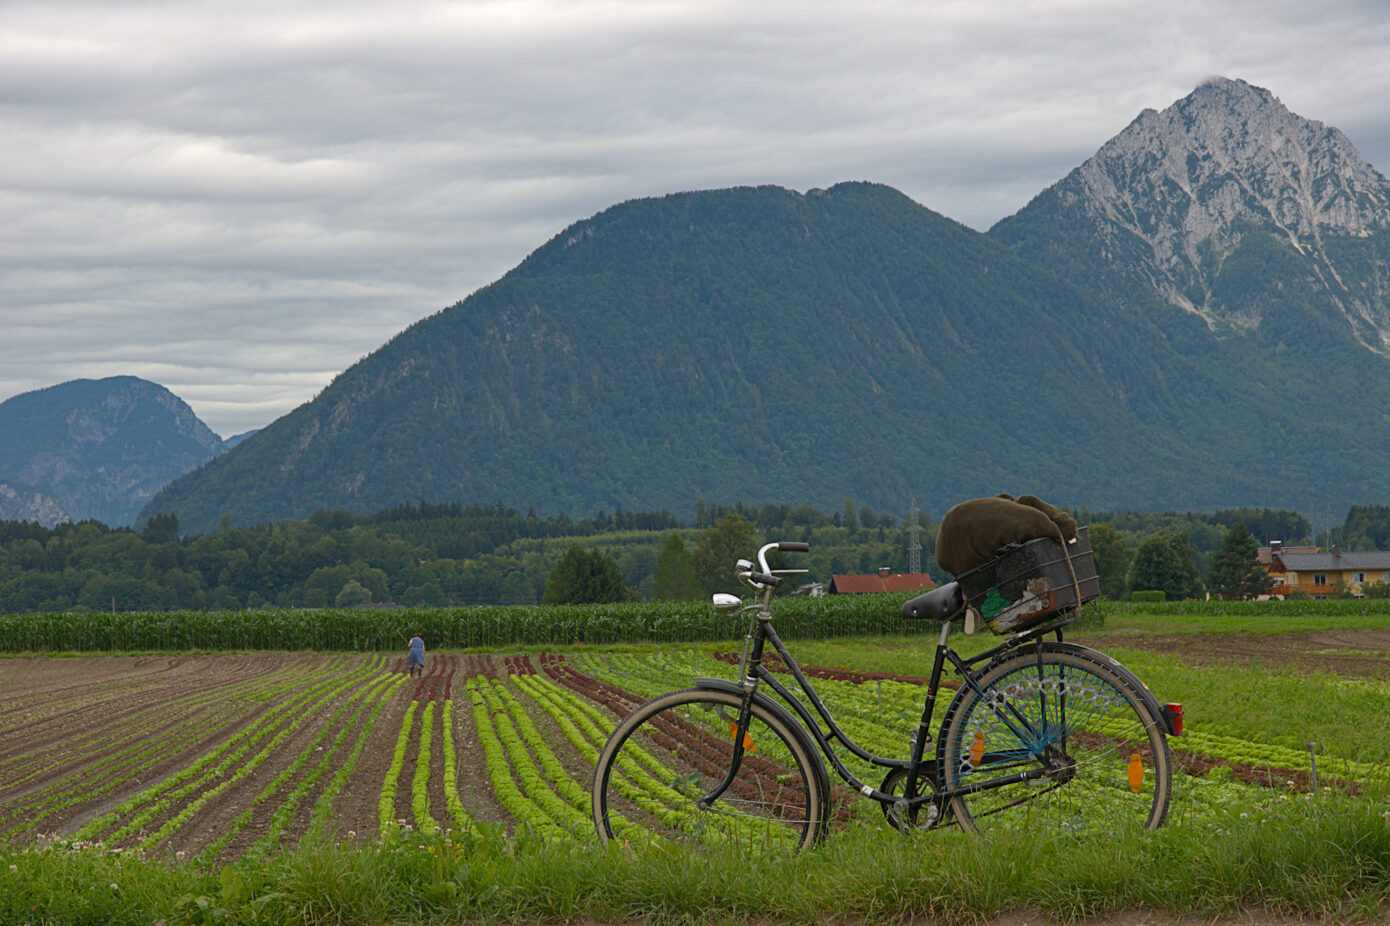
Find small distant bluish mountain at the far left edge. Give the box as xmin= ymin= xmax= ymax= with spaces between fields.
xmin=0 ymin=377 xmax=222 ymax=526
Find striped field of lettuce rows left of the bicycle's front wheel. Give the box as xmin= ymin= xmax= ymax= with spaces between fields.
xmin=0 ymin=649 xmax=945 ymax=862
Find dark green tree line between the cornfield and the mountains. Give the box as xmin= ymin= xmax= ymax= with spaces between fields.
xmin=0 ymin=499 xmax=1390 ymax=612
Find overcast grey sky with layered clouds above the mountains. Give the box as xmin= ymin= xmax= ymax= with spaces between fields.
xmin=0 ymin=0 xmax=1390 ymax=437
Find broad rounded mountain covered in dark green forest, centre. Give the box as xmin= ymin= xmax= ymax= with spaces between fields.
xmin=145 ymin=177 xmax=1356 ymax=531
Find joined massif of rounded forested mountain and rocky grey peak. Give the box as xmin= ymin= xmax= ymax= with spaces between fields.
xmin=143 ymin=79 xmax=1390 ymax=530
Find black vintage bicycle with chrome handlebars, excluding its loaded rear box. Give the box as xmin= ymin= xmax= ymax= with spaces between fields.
xmin=592 ymin=528 xmax=1183 ymax=851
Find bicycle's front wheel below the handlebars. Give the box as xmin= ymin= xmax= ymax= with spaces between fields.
xmin=594 ymin=688 xmax=827 ymax=852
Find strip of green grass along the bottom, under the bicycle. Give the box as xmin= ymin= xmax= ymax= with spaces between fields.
xmin=0 ymin=795 xmax=1390 ymax=926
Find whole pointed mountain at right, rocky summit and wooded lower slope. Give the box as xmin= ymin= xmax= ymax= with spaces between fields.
xmin=990 ymin=78 xmax=1390 ymax=512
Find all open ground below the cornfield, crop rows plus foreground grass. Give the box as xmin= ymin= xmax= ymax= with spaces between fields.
xmin=0 ymin=608 xmax=1390 ymax=926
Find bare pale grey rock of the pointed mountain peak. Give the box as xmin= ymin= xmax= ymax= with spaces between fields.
xmin=1049 ymin=76 xmax=1390 ymax=350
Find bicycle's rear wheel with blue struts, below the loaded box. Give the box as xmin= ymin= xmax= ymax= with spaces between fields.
xmin=942 ymin=642 xmax=1172 ymax=836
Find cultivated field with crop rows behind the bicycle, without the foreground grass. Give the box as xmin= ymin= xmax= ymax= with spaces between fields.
xmin=0 ymin=628 xmax=1390 ymax=863
